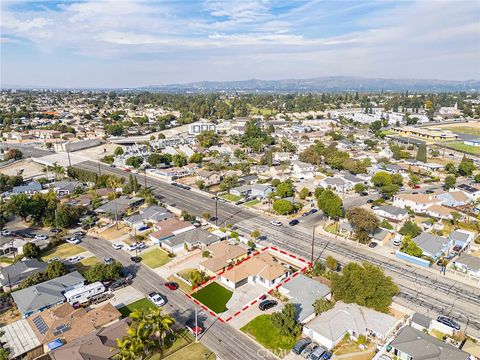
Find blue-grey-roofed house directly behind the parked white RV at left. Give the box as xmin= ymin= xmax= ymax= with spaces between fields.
xmin=12 ymin=271 xmax=85 ymax=318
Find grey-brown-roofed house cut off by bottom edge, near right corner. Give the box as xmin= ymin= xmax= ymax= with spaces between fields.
xmin=390 ymin=326 xmax=469 ymax=360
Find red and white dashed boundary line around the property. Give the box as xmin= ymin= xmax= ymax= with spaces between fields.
xmin=182 ymin=246 xmax=312 ymax=323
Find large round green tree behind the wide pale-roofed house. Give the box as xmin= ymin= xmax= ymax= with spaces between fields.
xmin=331 ymin=262 xmax=399 ymax=312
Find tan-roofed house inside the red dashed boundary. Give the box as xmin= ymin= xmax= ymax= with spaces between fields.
xmin=220 ymin=252 xmax=291 ymax=289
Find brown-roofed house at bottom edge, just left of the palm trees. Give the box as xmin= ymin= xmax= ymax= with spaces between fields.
xmin=50 ymin=318 xmax=129 ymax=360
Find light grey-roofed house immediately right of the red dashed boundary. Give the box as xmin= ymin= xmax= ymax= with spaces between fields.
xmin=278 ymin=274 xmax=331 ymax=324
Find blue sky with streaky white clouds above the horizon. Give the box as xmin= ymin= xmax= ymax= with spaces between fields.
xmin=0 ymin=0 xmax=480 ymax=87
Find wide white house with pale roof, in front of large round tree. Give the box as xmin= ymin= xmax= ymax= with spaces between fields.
xmin=303 ymin=301 xmax=400 ymax=349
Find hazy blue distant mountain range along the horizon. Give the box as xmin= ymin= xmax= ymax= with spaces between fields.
xmin=140 ymin=76 xmax=480 ymax=93
